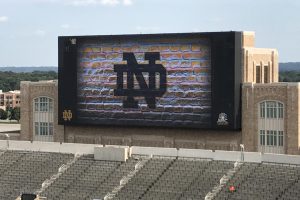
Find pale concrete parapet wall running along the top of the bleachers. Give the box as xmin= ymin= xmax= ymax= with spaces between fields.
xmin=0 ymin=140 xmax=300 ymax=165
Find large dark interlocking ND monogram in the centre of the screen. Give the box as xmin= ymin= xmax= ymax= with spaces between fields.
xmin=114 ymin=52 xmax=167 ymax=109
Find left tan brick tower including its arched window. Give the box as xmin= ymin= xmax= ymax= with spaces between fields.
xmin=20 ymin=81 xmax=63 ymax=141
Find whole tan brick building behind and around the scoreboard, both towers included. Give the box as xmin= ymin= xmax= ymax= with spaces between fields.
xmin=21 ymin=32 xmax=300 ymax=154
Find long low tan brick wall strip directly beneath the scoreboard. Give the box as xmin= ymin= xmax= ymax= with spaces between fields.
xmin=65 ymin=126 xmax=241 ymax=150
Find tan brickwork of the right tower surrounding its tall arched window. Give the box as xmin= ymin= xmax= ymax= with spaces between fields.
xmin=242 ymin=83 xmax=300 ymax=154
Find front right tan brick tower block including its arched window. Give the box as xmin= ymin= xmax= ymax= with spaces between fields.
xmin=242 ymin=83 xmax=300 ymax=154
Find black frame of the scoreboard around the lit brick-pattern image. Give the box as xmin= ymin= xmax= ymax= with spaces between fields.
xmin=58 ymin=32 xmax=242 ymax=130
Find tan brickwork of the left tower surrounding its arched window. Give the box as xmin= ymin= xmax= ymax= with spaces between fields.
xmin=20 ymin=81 xmax=63 ymax=142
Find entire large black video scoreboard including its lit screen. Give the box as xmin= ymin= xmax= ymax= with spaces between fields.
xmin=58 ymin=32 xmax=242 ymax=130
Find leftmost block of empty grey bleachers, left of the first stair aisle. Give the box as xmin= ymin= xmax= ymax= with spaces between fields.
xmin=0 ymin=151 xmax=74 ymax=200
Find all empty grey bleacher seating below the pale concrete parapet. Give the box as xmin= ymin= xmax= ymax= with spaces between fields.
xmin=0 ymin=150 xmax=300 ymax=200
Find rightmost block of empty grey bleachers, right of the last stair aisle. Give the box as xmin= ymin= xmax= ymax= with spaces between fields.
xmin=216 ymin=163 xmax=300 ymax=199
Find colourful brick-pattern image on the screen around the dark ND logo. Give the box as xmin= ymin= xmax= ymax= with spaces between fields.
xmin=77 ymin=39 xmax=211 ymax=128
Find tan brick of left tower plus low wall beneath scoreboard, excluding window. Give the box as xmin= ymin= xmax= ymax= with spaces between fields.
xmin=21 ymin=82 xmax=241 ymax=150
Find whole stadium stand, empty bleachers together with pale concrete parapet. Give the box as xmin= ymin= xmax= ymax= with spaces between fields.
xmin=0 ymin=141 xmax=300 ymax=200
